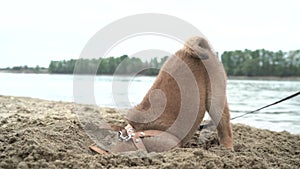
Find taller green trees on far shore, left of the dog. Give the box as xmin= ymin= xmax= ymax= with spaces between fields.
xmin=48 ymin=55 xmax=168 ymax=76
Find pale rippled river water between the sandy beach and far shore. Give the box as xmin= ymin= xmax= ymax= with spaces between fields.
xmin=0 ymin=73 xmax=300 ymax=134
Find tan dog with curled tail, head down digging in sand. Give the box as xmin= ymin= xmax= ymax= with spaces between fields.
xmin=111 ymin=36 xmax=233 ymax=153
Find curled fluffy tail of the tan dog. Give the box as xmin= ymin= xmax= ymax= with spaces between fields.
xmin=184 ymin=36 xmax=211 ymax=59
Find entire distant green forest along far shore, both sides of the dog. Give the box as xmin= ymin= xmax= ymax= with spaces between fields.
xmin=2 ymin=49 xmax=300 ymax=77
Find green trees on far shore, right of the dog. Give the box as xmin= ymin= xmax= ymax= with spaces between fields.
xmin=221 ymin=49 xmax=300 ymax=77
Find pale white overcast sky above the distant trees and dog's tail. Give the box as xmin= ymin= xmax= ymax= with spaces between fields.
xmin=0 ymin=0 xmax=300 ymax=68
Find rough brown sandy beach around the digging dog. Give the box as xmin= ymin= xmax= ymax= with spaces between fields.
xmin=0 ymin=96 xmax=300 ymax=169
